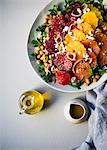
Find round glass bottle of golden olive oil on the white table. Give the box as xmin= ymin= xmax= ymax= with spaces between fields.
xmin=19 ymin=90 xmax=47 ymax=114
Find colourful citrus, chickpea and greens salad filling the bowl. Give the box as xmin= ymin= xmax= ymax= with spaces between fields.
xmin=32 ymin=0 xmax=107 ymax=89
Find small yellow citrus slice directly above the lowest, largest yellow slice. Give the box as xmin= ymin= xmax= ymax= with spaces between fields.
xmin=72 ymin=28 xmax=86 ymax=41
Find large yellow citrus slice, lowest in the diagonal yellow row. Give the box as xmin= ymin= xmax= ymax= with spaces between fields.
xmin=66 ymin=41 xmax=86 ymax=59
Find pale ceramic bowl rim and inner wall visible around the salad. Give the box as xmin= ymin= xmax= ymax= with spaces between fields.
xmin=27 ymin=0 xmax=107 ymax=93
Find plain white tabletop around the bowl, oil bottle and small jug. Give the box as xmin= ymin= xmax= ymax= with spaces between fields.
xmin=0 ymin=0 xmax=88 ymax=150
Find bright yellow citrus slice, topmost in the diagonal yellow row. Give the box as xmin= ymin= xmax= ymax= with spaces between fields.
xmin=81 ymin=11 xmax=98 ymax=27
